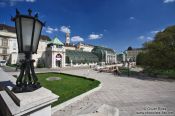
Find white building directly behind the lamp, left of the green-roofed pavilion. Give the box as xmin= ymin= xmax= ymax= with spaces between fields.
xmin=0 ymin=24 xmax=49 ymax=66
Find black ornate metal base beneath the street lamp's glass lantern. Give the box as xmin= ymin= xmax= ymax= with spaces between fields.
xmin=12 ymin=54 xmax=41 ymax=93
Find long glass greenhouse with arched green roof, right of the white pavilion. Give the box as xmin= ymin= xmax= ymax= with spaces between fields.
xmin=66 ymin=46 xmax=117 ymax=64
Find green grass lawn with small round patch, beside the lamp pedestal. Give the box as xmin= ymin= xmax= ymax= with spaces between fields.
xmin=37 ymin=73 xmax=100 ymax=106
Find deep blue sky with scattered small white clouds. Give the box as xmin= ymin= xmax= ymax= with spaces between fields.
xmin=0 ymin=0 xmax=175 ymax=52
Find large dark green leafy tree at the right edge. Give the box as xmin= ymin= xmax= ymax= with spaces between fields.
xmin=138 ymin=26 xmax=175 ymax=70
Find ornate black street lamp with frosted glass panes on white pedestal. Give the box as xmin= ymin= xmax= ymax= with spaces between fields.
xmin=12 ymin=9 xmax=44 ymax=93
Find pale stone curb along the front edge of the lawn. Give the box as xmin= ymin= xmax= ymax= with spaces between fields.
xmin=52 ymin=83 xmax=102 ymax=114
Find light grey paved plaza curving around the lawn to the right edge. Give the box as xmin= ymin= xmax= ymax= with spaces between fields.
xmin=53 ymin=69 xmax=175 ymax=116
